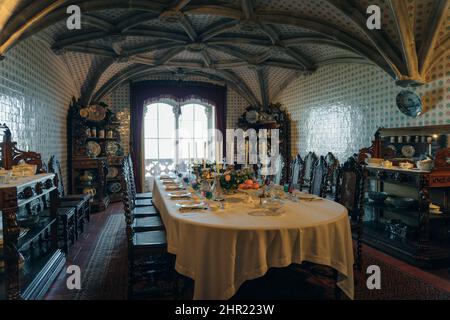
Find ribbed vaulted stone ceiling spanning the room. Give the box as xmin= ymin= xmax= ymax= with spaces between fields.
xmin=0 ymin=0 xmax=450 ymax=107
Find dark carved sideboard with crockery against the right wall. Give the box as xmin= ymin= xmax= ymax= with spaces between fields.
xmin=359 ymin=126 xmax=450 ymax=268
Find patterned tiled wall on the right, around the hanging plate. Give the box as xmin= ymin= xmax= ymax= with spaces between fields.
xmin=278 ymin=55 xmax=450 ymax=161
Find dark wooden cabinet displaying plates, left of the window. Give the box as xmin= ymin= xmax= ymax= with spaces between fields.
xmin=68 ymin=101 xmax=123 ymax=211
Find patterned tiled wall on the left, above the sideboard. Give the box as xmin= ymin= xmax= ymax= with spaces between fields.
xmin=0 ymin=39 xmax=78 ymax=185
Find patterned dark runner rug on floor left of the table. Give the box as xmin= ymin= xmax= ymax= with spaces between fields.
xmin=74 ymin=214 xmax=127 ymax=300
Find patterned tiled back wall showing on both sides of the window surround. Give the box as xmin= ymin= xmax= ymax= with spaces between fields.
xmin=103 ymin=84 xmax=249 ymax=153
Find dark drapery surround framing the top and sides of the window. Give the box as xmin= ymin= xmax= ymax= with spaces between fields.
xmin=130 ymin=81 xmax=227 ymax=192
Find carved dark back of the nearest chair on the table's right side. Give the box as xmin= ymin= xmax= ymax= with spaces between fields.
xmin=335 ymin=157 xmax=365 ymax=223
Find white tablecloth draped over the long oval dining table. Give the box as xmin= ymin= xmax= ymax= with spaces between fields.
xmin=153 ymin=179 xmax=354 ymax=300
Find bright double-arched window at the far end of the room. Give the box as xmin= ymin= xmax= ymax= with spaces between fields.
xmin=144 ymin=99 xmax=215 ymax=189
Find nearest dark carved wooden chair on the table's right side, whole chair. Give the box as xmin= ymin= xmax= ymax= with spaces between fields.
xmin=335 ymin=157 xmax=365 ymax=270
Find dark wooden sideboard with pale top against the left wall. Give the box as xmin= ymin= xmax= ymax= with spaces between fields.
xmin=0 ymin=174 xmax=66 ymax=300
